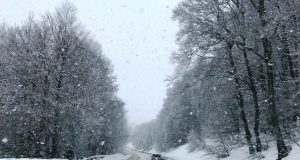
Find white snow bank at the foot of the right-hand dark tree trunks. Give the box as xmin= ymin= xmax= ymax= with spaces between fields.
xmin=164 ymin=145 xmax=300 ymax=160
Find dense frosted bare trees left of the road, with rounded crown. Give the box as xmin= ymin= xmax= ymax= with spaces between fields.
xmin=0 ymin=3 xmax=127 ymax=158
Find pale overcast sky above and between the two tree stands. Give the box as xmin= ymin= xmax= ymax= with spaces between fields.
xmin=0 ymin=0 xmax=180 ymax=124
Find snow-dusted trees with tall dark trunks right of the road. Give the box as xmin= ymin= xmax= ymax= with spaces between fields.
xmin=133 ymin=0 xmax=300 ymax=160
